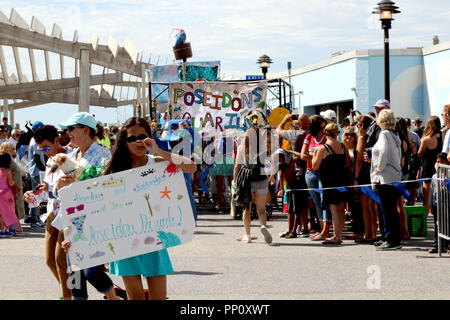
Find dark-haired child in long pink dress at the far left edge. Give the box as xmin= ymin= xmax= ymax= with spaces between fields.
xmin=0 ymin=153 xmax=19 ymax=238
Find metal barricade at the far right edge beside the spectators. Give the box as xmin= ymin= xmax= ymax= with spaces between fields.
xmin=436 ymin=164 xmax=450 ymax=256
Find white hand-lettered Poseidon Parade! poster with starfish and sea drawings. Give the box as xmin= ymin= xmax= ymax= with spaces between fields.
xmin=59 ymin=161 xmax=195 ymax=269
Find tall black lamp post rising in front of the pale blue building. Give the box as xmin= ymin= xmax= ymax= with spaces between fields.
xmin=372 ymin=0 xmax=400 ymax=101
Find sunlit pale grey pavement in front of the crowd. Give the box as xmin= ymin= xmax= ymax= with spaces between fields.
xmin=0 ymin=212 xmax=450 ymax=300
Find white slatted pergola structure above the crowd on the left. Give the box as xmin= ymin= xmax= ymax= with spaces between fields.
xmin=0 ymin=9 xmax=150 ymax=123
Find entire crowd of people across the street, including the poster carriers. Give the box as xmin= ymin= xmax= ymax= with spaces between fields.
xmin=0 ymin=99 xmax=450 ymax=299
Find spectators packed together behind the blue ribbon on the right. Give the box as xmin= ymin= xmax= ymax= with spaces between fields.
xmin=233 ymin=99 xmax=450 ymax=253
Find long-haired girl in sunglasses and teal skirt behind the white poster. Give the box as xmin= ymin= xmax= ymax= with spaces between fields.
xmin=105 ymin=117 xmax=197 ymax=300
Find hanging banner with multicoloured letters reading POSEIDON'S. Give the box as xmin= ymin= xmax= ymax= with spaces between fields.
xmin=169 ymin=82 xmax=267 ymax=132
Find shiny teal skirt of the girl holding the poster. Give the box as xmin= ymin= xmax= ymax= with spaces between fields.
xmin=109 ymin=249 xmax=173 ymax=277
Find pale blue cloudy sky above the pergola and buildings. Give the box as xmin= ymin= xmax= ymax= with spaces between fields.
xmin=0 ymin=0 xmax=450 ymax=126
